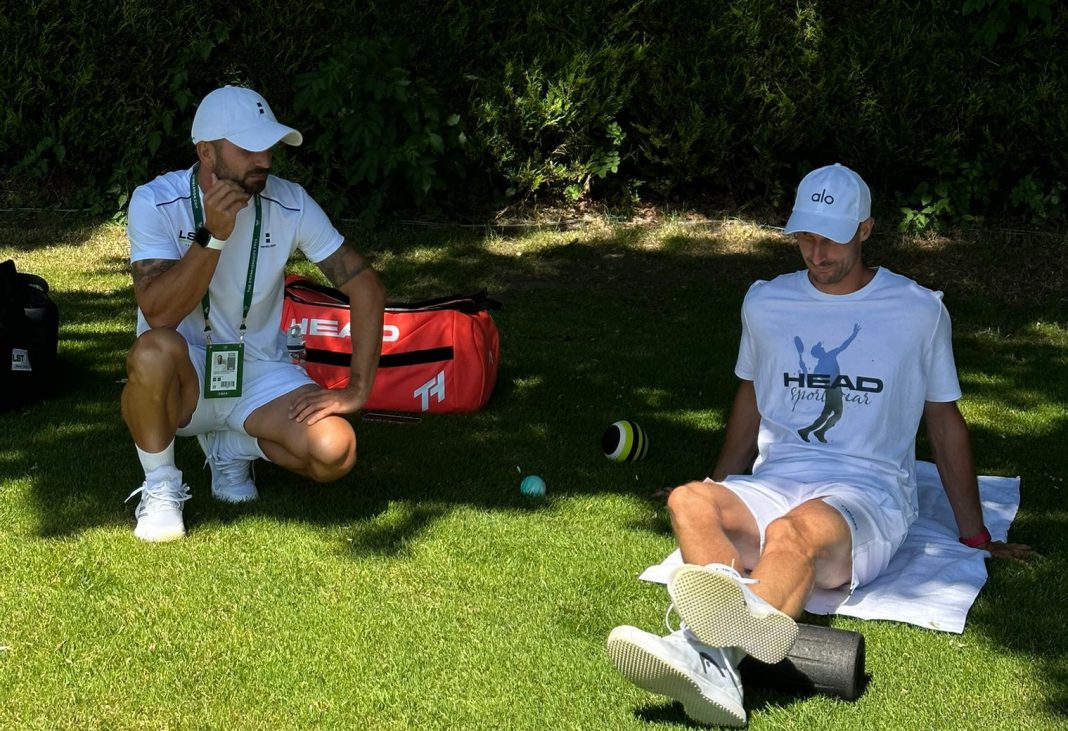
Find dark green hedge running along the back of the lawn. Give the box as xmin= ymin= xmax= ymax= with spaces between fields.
xmin=0 ymin=0 xmax=1068 ymax=228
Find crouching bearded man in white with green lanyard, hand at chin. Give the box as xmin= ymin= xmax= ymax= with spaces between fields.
xmin=122 ymin=87 xmax=384 ymax=541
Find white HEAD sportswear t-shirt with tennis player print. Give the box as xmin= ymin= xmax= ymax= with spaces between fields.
xmin=735 ymin=268 xmax=960 ymax=520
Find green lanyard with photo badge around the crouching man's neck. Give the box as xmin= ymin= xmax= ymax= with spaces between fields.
xmin=189 ymin=162 xmax=263 ymax=399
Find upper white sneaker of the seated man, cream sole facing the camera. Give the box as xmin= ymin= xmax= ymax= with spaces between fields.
xmin=668 ymin=563 xmax=798 ymax=665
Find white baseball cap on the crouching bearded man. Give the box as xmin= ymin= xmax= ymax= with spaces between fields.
xmin=193 ymin=87 xmax=304 ymax=152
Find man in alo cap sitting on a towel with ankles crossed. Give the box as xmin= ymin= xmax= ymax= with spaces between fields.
xmin=608 ymin=165 xmax=1031 ymax=726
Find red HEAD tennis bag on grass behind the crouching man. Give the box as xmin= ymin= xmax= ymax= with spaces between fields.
xmin=281 ymin=275 xmax=501 ymax=414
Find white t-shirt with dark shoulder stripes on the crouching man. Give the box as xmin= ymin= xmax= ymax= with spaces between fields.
xmin=127 ymin=164 xmax=343 ymax=360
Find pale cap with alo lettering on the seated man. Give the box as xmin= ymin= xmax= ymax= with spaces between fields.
xmin=783 ymin=162 xmax=871 ymax=244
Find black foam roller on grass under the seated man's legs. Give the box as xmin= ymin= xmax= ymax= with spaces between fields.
xmin=739 ymin=624 xmax=866 ymax=700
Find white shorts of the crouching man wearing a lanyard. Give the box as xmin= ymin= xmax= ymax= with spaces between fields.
xmin=177 ymin=345 xmax=315 ymax=436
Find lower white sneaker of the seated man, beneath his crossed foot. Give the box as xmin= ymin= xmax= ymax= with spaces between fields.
xmin=608 ymin=626 xmax=745 ymax=726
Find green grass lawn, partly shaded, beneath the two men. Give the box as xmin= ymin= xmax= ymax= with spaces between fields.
xmin=0 ymin=217 xmax=1068 ymax=731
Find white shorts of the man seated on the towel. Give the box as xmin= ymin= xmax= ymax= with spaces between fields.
xmin=720 ymin=475 xmax=909 ymax=591
